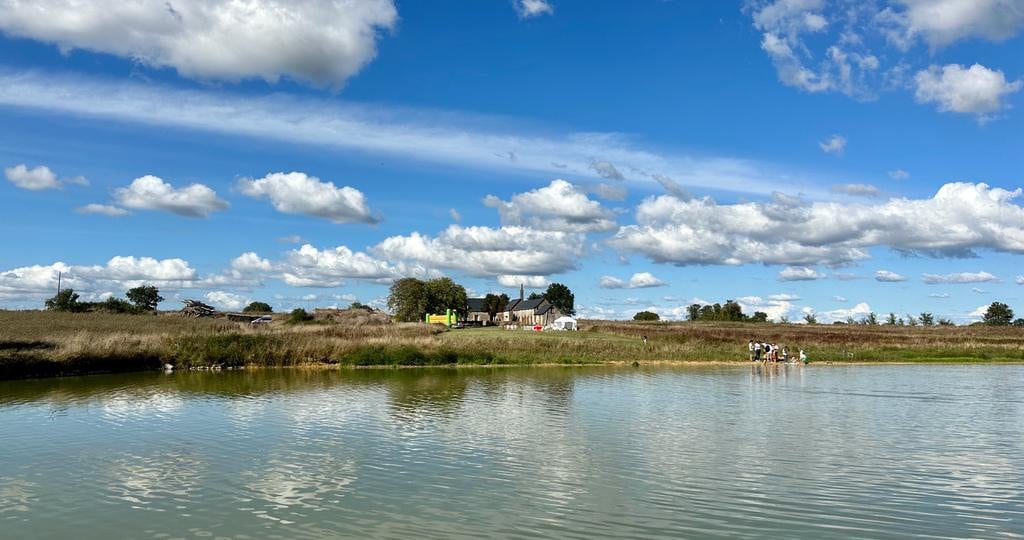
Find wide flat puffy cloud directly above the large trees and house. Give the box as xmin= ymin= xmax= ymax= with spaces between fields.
xmin=371 ymin=224 xmax=586 ymax=278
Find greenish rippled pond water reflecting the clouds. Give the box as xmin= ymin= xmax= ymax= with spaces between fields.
xmin=0 ymin=365 xmax=1024 ymax=539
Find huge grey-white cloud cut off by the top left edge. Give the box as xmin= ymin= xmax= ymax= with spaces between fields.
xmin=0 ymin=0 xmax=398 ymax=88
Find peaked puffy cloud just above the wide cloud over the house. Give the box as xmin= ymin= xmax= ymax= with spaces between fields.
xmin=483 ymin=180 xmax=616 ymax=233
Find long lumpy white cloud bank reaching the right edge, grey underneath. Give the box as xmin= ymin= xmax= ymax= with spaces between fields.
xmin=608 ymin=182 xmax=1024 ymax=266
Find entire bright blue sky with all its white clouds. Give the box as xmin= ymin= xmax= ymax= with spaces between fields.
xmin=0 ymin=0 xmax=1024 ymax=322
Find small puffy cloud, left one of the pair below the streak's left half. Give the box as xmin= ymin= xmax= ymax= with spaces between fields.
xmin=114 ymin=174 xmax=227 ymax=217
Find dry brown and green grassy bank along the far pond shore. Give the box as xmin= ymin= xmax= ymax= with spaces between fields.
xmin=0 ymin=311 xmax=1024 ymax=378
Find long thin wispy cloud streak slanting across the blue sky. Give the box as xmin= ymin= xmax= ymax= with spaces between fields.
xmin=0 ymin=70 xmax=821 ymax=195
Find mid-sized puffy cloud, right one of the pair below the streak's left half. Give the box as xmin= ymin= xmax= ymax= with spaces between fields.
xmin=239 ymin=172 xmax=380 ymax=223
